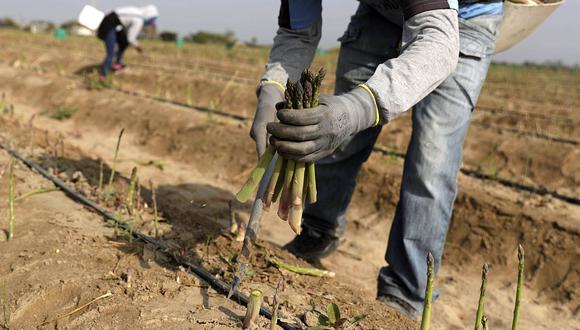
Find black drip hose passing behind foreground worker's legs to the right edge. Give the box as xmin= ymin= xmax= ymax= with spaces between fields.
xmin=373 ymin=146 xmax=580 ymax=205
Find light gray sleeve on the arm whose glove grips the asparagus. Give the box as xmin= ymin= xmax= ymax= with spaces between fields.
xmin=367 ymin=9 xmax=459 ymax=122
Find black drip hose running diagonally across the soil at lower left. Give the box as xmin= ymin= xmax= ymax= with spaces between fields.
xmin=0 ymin=143 xmax=301 ymax=330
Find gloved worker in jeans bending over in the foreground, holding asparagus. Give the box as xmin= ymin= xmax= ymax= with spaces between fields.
xmin=250 ymin=0 xmax=503 ymax=319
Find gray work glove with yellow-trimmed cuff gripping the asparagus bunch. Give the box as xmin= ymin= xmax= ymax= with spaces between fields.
xmin=268 ymin=87 xmax=377 ymax=162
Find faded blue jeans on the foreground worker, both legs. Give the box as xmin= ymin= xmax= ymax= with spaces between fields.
xmin=304 ymin=4 xmax=502 ymax=311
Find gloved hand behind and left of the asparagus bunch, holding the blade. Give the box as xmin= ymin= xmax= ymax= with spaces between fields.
xmin=250 ymin=83 xmax=284 ymax=157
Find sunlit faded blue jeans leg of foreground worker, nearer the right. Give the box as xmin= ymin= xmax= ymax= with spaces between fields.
xmin=378 ymin=15 xmax=501 ymax=311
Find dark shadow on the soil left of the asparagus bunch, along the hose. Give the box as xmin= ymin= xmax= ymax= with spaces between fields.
xmin=39 ymin=156 xmax=249 ymax=284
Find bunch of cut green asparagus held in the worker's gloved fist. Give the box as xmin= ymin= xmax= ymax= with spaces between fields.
xmin=236 ymin=68 xmax=326 ymax=234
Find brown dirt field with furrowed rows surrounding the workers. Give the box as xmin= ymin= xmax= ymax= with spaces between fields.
xmin=0 ymin=31 xmax=580 ymax=329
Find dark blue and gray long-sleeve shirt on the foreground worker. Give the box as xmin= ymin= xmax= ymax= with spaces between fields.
xmin=263 ymin=0 xmax=459 ymax=123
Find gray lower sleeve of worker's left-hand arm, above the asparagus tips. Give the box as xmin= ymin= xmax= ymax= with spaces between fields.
xmin=262 ymin=19 xmax=322 ymax=85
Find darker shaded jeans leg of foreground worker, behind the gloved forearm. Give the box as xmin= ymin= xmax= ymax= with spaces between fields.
xmin=303 ymin=4 xmax=401 ymax=237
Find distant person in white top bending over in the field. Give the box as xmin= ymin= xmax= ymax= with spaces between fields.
xmin=97 ymin=5 xmax=159 ymax=77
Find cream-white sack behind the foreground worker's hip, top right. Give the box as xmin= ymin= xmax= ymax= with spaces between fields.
xmin=495 ymin=0 xmax=564 ymax=53
